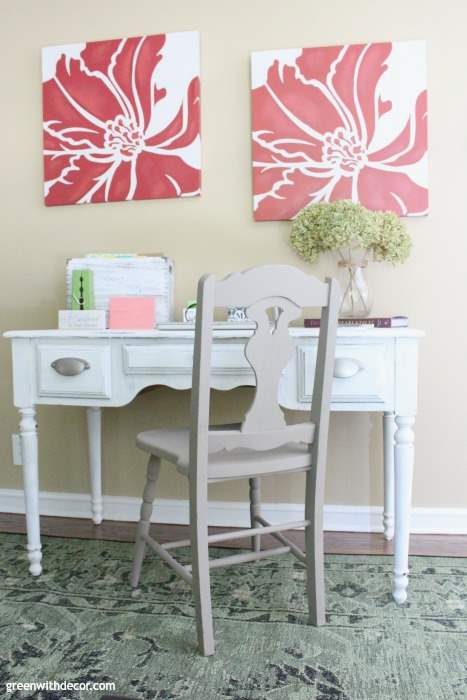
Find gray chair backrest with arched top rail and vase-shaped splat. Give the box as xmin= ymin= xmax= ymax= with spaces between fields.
xmin=190 ymin=265 xmax=339 ymax=476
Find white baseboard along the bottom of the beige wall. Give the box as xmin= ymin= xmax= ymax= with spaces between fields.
xmin=0 ymin=489 xmax=467 ymax=535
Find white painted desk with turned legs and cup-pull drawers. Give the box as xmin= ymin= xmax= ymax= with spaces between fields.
xmin=5 ymin=328 xmax=423 ymax=603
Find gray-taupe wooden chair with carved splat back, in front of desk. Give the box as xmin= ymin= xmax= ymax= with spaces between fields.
xmin=132 ymin=265 xmax=339 ymax=656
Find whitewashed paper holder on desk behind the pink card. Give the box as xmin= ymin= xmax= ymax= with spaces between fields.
xmin=66 ymin=254 xmax=174 ymax=324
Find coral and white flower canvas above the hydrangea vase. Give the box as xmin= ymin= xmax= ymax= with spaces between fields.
xmin=251 ymin=41 xmax=428 ymax=221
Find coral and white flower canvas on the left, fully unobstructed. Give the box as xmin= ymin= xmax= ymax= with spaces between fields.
xmin=42 ymin=32 xmax=201 ymax=205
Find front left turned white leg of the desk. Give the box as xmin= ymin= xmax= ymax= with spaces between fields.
xmin=19 ymin=406 xmax=42 ymax=576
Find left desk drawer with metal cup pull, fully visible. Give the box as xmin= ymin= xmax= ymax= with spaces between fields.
xmin=36 ymin=344 xmax=111 ymax=399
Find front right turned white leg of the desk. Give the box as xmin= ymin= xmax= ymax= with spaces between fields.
xmin=392 ymin=416 xmax=415 ymax=603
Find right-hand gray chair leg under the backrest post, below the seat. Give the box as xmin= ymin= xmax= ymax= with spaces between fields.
xmin=305 ymin=470 xmax=326 ymax=627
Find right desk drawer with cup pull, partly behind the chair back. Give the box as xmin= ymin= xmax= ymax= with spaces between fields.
xmin=297 ymin=343 xmax=394 ymax=403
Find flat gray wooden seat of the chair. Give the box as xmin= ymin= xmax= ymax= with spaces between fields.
xmin=136 ymin=428 xmax=311 ymax=481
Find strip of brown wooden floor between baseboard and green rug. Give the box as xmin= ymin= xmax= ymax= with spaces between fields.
xmin=0 ymin=513 xmax=467 ymax=557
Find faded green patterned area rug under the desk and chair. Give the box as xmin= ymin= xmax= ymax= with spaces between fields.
xmin=0 ymin=534 xmax=467 ymax=700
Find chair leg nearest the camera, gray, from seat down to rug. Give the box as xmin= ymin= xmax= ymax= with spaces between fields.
xmin=190 ymin=480 xmax=214 ymax=656
